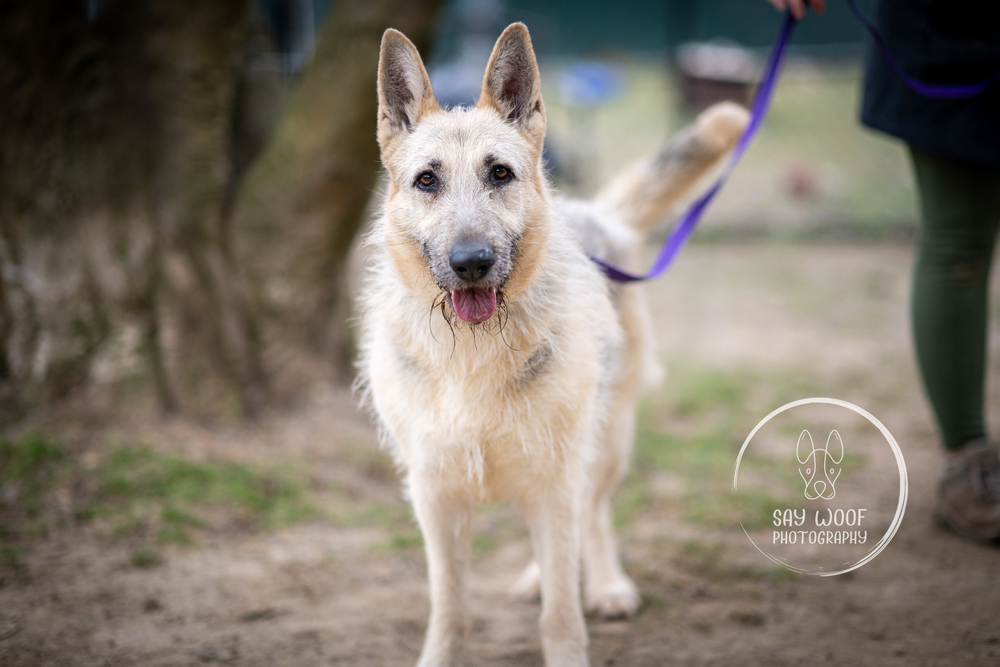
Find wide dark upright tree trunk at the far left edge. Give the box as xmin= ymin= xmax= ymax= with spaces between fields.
xmin=0 ymin=0 xmax=262 ymax=416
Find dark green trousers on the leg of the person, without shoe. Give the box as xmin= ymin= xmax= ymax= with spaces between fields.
xmin=910 ymin=146 xmax=1000 ymax=449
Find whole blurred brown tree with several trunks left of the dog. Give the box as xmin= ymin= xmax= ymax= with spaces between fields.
xmin=0 ymin=0 xmax=440 ymax=423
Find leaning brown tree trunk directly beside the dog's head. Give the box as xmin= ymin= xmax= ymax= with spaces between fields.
xmin=236 ymin=0 xmax=441 ymax=379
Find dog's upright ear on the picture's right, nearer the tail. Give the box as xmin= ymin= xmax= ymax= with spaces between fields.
xmin=478 ymin=23 xmax=545 ymax=149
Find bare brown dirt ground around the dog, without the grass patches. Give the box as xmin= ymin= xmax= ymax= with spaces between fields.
xmin=0 ymin=243 xmax=1000 ymax=667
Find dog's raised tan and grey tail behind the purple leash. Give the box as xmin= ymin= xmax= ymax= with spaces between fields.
xmin=594 ymin=102 xmax=750 ymax=236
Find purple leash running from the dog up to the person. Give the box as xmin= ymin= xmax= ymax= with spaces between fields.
xmin=590 ymin=0 xmax=1000 ymax=283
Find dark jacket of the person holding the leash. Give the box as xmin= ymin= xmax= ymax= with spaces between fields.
xmin=861 ymin=0 xmax=1000 ymax=171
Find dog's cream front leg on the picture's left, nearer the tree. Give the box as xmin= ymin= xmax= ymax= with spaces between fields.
xmin=408 ymin=474 xmax=473 ymax=667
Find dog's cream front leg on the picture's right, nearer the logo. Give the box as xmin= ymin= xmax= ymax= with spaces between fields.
xmin=527 ymin=472 xmax=589 ymax=667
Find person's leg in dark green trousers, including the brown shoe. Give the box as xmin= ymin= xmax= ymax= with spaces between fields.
xmin=910 ymin=147 xmax=1000 ymax=539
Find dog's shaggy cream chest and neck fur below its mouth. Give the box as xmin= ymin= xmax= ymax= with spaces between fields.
xmin=362 ymin=222 xmax=622 ymax=498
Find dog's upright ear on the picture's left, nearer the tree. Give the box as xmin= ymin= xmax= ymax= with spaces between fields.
xmin=378 ymin=28 xmax=437 ymax=151
